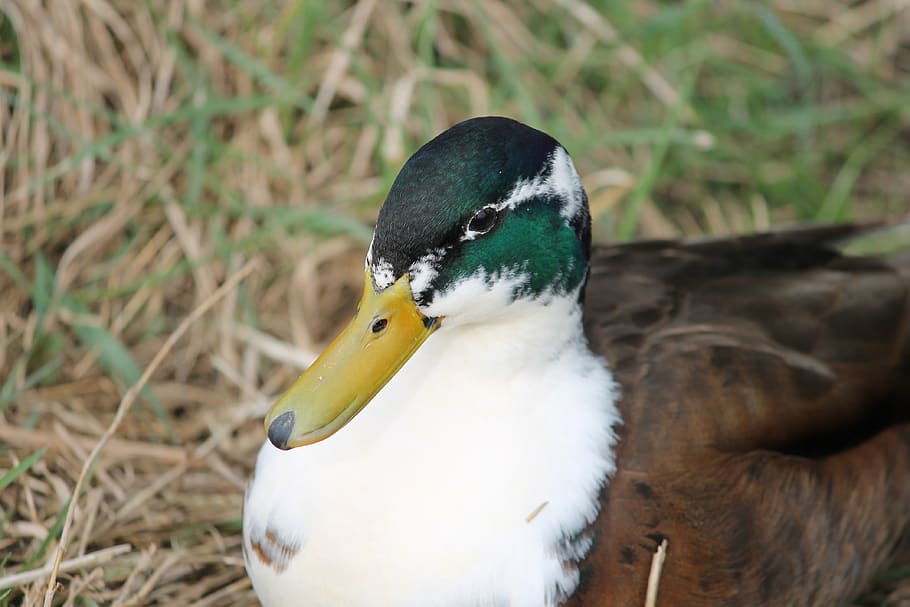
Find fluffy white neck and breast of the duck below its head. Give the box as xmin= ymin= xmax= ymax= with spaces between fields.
xmin=244 ymin=296 xmax=619 ymax=607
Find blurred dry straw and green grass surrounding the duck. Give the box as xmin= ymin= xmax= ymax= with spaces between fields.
xmin=0 ymin=0 xmax=910 ymax=607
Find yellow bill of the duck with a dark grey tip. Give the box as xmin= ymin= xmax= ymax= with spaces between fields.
xmin=265 ymin=270 xmax=439 ymax=449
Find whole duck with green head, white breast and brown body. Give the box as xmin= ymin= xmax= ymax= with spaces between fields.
xmin=242 ymin=116 xmax=910 ymax=607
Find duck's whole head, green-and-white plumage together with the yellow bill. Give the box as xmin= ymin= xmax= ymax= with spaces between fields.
xmin=265 ymin=117 xmax=591 ymax=449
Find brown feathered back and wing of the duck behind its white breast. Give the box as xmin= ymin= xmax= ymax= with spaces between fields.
xmin=567 ymin=228 xmax=910 ymax=607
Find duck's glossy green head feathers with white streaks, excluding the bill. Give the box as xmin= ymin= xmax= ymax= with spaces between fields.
xmin=367 ymin=117 xmax=590 ymax=316
